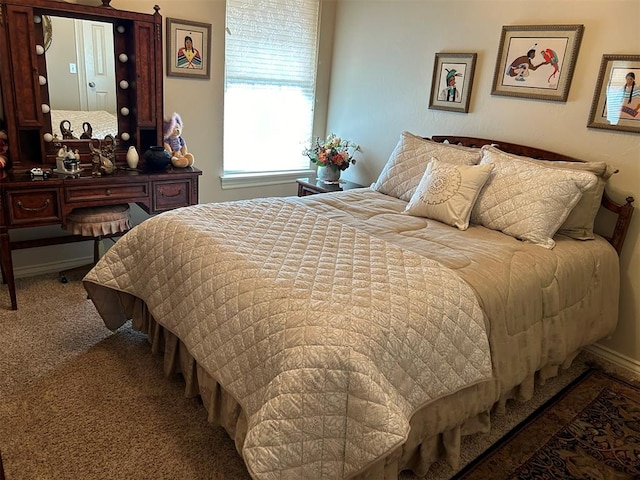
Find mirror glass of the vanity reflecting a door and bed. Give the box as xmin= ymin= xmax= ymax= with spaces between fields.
xmin=45 ymin=17 xmax=118 ymax=138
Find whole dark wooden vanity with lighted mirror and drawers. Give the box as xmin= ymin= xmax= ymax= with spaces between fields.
xmin=0 ymin=0 xmax=202 ymax=310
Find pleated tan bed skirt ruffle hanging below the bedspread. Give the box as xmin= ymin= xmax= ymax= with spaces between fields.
xmin=127 ymin=293 xmax=578 ymax=480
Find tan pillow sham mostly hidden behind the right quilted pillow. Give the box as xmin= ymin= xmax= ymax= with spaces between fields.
xmin=486 ymin=147 xmax=615 ymax=240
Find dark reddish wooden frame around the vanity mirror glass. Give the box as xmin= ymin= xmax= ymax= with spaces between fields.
xmin=0 ymin=0 xmax=163 ymax=167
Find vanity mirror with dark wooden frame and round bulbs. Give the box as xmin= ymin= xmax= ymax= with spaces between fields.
xmin=0 ymin=0 xmax=163 ymax=169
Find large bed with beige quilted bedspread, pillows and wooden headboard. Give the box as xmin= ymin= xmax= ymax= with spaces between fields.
xmin=84 ymin=132 xmax=633 ymax=479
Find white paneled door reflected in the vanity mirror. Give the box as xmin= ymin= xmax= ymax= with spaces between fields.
xmin=76 ymin=20 xmax=116 ymax=114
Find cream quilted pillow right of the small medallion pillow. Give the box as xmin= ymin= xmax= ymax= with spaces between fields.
xmin=471 ymin=146 xmax=598 ymax=248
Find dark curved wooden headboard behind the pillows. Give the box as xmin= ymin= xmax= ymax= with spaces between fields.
xmin=431 ymin=135 xmax=634 ymax=255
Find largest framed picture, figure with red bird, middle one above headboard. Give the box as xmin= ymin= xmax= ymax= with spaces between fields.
xmin=491 ymin=25 xmax=584 ymax=102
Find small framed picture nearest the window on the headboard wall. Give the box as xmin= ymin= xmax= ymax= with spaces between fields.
xmin=429 ymin=53 xmax=478 ymax=113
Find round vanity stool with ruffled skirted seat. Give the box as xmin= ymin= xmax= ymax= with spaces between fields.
xmin=59 ymin=203 xmax=131 ymax=283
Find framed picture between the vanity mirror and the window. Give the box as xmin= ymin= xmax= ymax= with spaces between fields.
xmin=166 ymin=18 xmax=211 ymax=78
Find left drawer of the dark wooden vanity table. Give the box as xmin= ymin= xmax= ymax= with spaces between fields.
xmin=7 ymin=188 xmax=62 ymax=226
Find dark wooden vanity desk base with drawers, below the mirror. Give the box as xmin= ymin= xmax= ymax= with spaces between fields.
xmin=0 ymin=167 xmax=202 ymax=310
